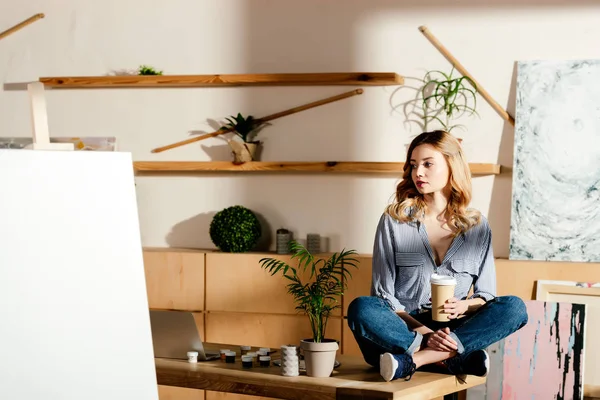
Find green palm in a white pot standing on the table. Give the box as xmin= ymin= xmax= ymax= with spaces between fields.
xmin=260 ymin=240 xmax=357 ymax=377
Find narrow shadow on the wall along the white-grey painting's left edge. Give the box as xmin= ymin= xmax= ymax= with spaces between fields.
xmin=488 ymin=62 xmax=517 ymax=258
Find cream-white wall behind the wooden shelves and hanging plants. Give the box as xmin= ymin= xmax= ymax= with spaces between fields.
xmin=0 ymin=0 xmax=600 ymax=256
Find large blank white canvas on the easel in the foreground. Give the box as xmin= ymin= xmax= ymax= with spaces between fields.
xmin=0 ymin=150 xmax=158 ymax=400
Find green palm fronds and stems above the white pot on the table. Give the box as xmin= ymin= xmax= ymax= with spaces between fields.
xmin=260 ymin=241 xmax=358 ymax=343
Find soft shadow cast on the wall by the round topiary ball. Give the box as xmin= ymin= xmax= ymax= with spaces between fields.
xmin=165 ymin=211 xmax=273 ymax=251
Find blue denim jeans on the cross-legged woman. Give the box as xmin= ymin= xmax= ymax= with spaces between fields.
xmin=348 ymin=296 xmax=528 ymax=367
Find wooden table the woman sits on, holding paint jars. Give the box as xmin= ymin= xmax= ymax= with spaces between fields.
xmin=155 ymin=344 xmax=485 ymax=400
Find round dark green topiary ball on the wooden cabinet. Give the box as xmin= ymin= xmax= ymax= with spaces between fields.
xmin=209 ymin=206 xmax=261 ymax=253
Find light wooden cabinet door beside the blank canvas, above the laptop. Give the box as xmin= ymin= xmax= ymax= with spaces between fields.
xmin=143 ymin=250 xmax=204 ymax=311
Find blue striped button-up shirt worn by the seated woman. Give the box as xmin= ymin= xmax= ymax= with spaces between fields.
xmin=371 ymin=213 xmax=496 ymax=312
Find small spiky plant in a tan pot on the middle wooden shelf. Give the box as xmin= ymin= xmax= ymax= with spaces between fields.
xmin=221 ymin=113 xmax=268 ymax=163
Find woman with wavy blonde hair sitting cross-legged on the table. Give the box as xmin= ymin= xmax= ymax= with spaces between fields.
xmin=348 ymin=131 xmax=527 ymax=381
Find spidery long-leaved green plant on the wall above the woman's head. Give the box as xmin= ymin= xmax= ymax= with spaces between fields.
xmin=421 ymin=68 xmax=477 ymax=132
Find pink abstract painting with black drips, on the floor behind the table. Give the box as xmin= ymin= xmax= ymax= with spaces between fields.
xmin=467 ymin=300 xmax=586 ymax=400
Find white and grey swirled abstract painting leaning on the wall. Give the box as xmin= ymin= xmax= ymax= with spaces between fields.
xmin=509 ymin=60 xmax=600 ymax=262
